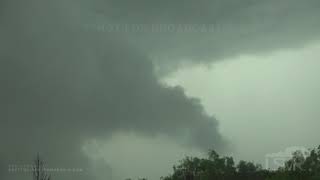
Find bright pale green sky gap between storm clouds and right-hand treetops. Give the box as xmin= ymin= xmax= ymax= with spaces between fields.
xmin=164 ymin=44 xmax=320 ymax=168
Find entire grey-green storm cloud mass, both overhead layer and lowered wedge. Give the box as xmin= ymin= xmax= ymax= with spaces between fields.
xmin=0 ymin=0 xmax=320 ymax=180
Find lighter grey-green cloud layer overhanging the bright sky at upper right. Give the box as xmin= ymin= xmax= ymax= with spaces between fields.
xmin=93 ymin=0 xmax=320 ymax=71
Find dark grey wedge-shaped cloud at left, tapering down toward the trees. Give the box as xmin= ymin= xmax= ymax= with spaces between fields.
xmin=0 ymin=0 xmax=226 ymax=179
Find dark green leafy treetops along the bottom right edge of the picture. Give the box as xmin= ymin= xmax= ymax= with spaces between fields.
xmin=161 ymin=146 xmax=320 ymax=180
